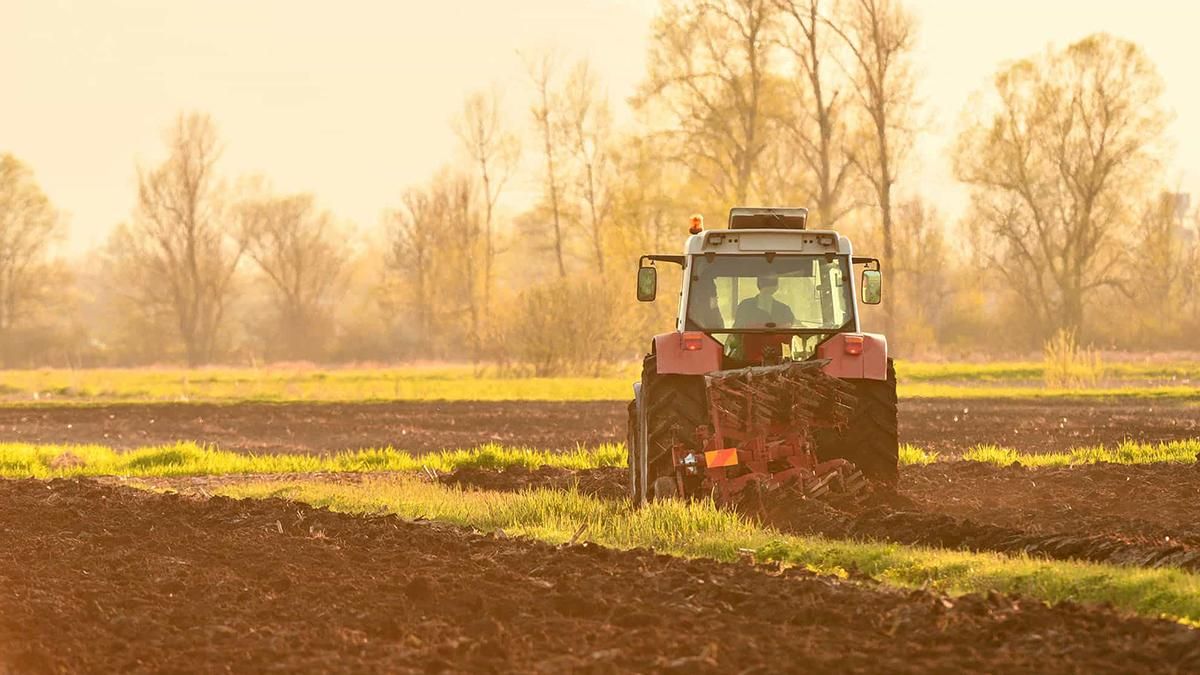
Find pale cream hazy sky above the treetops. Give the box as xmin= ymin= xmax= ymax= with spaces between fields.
xmin=0 ymin=0 xmax=1200 ymax=251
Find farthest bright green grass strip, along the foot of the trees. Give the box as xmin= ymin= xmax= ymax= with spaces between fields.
xmin=0 ymin=362 xmax=1200 ymax=405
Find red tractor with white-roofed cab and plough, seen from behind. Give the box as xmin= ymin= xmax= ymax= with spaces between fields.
xmin=628 ymin=208 xmax=899 ymax=504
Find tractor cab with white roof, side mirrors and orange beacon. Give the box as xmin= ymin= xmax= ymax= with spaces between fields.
xmin=638 ymin=208 xmax=881 ymax=368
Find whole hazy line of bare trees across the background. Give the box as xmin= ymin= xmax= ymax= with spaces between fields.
xmin=0 ymin=0 xmax=1200 ymax=367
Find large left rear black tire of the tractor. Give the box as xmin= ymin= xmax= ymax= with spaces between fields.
xmin=642 ymin=354 xmax=708 ymax=485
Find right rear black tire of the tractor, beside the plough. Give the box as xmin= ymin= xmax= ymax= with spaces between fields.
xmin=816 ymin=358 xmax=900 ymax=485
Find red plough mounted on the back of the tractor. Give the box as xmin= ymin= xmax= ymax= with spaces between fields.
xmin=674 ymin=360 xmax=865 ymax=503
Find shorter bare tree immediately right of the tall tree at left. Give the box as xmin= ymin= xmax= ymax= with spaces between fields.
xmin=238 ymin=187 xmax=349 ymax=358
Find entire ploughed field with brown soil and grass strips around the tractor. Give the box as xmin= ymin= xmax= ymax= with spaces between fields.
xmin=0 ymin=363 xmax=1200 ymax=673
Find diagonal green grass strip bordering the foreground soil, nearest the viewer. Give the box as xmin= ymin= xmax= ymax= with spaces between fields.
xmin=211 ymin=480 xmax=1200 ymax=621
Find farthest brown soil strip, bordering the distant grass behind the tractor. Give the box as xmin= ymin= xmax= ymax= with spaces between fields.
xmin=0 ymin=399 xmax=1200 ymax=455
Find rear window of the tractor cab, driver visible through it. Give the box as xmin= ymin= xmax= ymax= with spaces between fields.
xmin=688 ymin=255 xmax=853 ymax=331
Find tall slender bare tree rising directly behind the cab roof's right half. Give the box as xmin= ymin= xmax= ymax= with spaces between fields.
xmin=778 ymin=0 xmax=856 ymax=228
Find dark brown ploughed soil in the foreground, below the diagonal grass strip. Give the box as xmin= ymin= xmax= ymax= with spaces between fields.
xmin=0 ymin=480 xmax=1200 ymax=673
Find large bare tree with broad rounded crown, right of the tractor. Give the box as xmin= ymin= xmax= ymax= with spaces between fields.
xmin=955 ymin=34 xmax=1168 ymax=336
